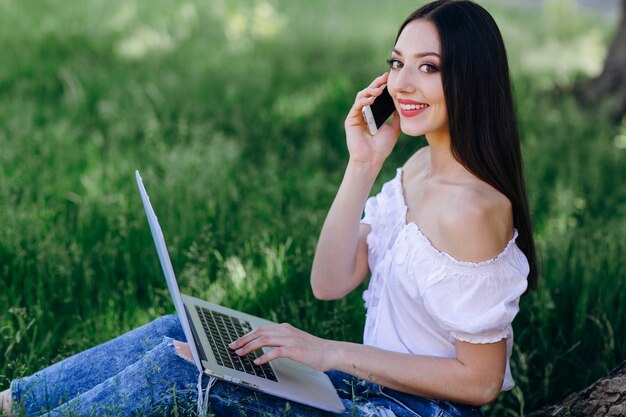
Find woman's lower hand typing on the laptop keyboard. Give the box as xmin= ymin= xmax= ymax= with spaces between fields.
xmin=230 ymin=323 xmax=339 ymax=371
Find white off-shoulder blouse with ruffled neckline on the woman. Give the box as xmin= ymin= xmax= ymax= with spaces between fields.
xmin=361 ymin=168 xmax=529 ymax=390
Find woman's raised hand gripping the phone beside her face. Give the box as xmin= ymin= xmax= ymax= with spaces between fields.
xmin=345 ymin=72 xmax=400 ymax=168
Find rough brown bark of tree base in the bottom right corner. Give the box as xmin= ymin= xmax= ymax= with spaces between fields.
xmin=526 ymin=361 xmax=626 ymax=417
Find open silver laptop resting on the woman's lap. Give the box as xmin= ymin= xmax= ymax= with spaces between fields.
xmin=135 ymin=171 xmax=344 ymax=413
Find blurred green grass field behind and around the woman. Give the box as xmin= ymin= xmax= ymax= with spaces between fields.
xmin=0 ymin=0 xmax=626 ymax=416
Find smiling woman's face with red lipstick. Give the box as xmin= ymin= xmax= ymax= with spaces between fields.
xmin=387 ymin=19 xmax=449 ymax=137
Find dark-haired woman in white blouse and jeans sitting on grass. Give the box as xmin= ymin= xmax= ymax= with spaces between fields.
xmin=4 ymin=0 xmax=536 ymax=416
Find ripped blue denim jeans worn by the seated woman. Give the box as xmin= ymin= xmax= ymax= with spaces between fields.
xmin=11 ymin=316 xmax=483 ymax=417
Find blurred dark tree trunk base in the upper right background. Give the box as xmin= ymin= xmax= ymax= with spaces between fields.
xmin=574 ymin=0 xmax=626 ymax=120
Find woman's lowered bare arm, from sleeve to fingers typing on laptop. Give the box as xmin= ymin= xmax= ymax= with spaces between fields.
xmin=231 ymin=324 xmax=506 ymax=405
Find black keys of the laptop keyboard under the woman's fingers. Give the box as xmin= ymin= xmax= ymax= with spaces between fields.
xmin=196 ymin=306 xmax=278 ymax=381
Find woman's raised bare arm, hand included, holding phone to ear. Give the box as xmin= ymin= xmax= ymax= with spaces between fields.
xmin=311 ymin=73 xmax=400 ymax=299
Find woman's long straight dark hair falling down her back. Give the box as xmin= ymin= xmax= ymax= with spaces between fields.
xmin=396 ymin=0 xmax=537 ymax=288
